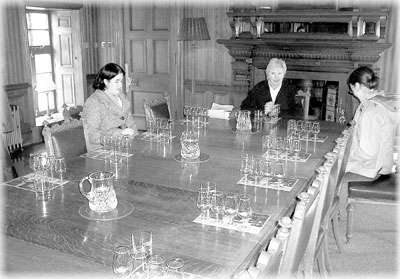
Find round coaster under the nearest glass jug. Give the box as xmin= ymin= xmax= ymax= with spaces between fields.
xmin=79 ymin=200 xmax=134 ymax=221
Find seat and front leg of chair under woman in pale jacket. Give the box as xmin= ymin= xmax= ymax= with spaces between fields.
xmin=346 ymin=173 xmax=399 ymax=242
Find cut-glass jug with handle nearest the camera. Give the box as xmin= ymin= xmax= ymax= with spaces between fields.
xmin=79 ymin=172 xmax=118 ymax=213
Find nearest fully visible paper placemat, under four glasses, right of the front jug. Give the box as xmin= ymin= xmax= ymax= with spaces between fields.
xmin=193 ymin=210 xmax=271 ymax=234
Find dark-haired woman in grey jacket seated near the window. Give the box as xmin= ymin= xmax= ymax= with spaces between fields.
xmin=82 ymin=63 xmax=138 ymax=151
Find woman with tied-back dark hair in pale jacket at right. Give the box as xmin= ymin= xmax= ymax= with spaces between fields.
xmin=346 ymin=66 xmax=399 ymax=178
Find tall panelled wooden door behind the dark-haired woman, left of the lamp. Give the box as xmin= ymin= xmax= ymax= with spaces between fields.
xmin=124 ymin=1 xmax=177 ymax=130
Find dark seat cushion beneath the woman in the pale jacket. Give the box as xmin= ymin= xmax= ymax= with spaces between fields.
xmin=349 ymin=174 xmax=397 ymax=200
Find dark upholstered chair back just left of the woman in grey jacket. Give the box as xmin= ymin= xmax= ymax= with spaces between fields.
xmin=51 ymin=125 xmax=87 ymax=158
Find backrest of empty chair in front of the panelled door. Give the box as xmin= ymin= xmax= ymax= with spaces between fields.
xmin=143 ymin=92 xmax=171 ymax=129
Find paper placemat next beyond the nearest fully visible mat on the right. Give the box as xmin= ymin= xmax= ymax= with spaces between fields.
xmin=237 ymin=175 xmax=298 ymax=192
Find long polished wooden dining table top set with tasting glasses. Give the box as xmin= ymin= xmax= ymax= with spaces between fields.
xmin=3 ymin=119 xmax=344 ymax=278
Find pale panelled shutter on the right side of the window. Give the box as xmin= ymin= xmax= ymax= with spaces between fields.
xmin=51 ymin=10 xmax=84 ymax=111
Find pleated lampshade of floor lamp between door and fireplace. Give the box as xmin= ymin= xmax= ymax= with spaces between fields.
xmin=178 ymin=17 xmax=210 ymax=41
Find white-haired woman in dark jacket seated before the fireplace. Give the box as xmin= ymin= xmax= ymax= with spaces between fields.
xmin=240 ymin=58 xmax=297 ymax=116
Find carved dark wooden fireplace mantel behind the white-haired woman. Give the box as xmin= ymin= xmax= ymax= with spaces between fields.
xmin=217 ymin=5 xmax=391 ymax=121
